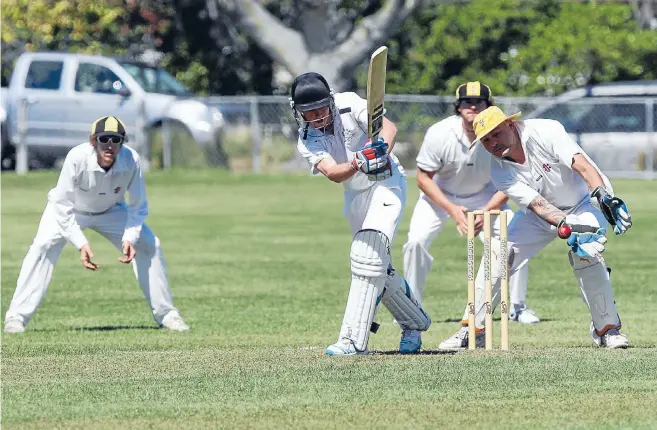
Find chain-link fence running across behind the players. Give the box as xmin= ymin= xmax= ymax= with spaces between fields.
xmin=3 ymin=95 xmax=657 ymax=179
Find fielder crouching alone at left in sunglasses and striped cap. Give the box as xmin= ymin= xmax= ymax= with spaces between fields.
xmin=5 ymin=116 xmax=189 ymax=333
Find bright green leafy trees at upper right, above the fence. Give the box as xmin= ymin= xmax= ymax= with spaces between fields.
xmin=388 ymin=0 xmax=657 ymax=95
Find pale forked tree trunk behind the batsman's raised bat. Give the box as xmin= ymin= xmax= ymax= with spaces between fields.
xmin=217 ymin=0 xmax=419 ymax=91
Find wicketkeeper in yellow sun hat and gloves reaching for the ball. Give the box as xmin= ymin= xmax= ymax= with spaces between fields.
xmin=440 ymin=106 xmax=632 ymax=349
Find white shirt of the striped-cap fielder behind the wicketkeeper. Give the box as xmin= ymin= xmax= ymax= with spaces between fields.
xmin=416 ymin=115 xmax=491 ymax=197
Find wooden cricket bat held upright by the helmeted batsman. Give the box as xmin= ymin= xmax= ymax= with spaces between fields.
xmin=367 ymin=46 xmax=388 ymax=142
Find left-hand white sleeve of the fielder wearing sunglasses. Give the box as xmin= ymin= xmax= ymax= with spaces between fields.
xmin=48 ymin=153 xmax=89 ymax=249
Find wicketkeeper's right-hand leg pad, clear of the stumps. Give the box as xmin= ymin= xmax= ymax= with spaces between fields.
xmin=568 ymin=251 xmax=621 ymax=336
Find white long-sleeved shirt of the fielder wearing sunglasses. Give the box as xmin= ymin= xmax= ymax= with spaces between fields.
xmin=48 ymin=142 xmax=148 ymax=249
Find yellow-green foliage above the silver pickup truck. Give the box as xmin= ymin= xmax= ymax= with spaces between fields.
xmin=2 ymin=0 xmax=173 ymax=85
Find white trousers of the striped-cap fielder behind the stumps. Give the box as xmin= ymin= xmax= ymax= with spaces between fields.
xmin=403 ymin=183 xmax=529 ymax=305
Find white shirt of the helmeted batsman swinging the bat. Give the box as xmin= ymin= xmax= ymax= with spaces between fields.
xmin=297 ymin=92 xmax=405 ymax=191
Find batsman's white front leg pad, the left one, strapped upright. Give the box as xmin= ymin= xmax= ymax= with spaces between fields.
xmin=340 ymin=230 xmax=390 ymax=351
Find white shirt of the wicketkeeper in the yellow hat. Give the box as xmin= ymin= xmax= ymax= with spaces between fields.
xmin=490 ymin=119 xmax=613 ymax=212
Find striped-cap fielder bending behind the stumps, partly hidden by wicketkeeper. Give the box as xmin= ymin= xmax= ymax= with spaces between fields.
xmin=403 ymin=82 xmax=540 ymax=336
